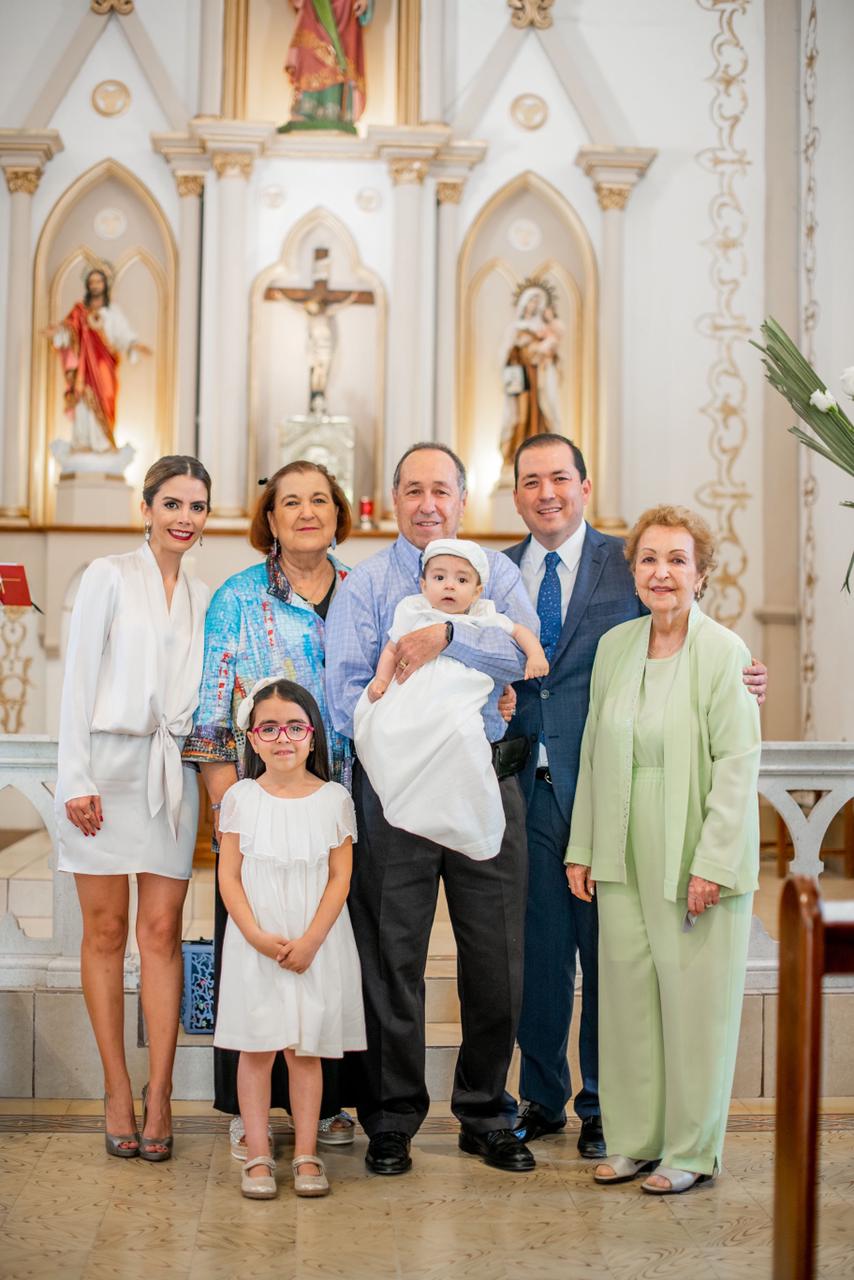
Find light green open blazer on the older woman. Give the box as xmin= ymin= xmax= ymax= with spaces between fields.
xmin=565 ymin=605 xmax=762 ymax=902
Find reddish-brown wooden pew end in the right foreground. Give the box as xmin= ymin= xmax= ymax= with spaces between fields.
xmin=772 ymin=876 xmax=854 ymax=1280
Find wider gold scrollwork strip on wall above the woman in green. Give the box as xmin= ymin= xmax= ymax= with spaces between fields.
xmin=697 ymin=0 xmax=753 ymax=627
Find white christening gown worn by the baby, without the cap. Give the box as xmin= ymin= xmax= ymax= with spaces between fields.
xmin=353 ymin=595 xmax=513 ymax=860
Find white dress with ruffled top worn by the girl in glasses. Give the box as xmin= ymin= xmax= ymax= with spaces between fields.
xmin=214 ymin=778 xmax=365 ymax=1057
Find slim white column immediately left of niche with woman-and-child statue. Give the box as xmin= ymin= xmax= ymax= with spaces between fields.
xmin=435 ymin=178 xmax=465 ymax=448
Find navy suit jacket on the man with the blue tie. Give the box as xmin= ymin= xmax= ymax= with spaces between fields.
xmin=504 ymin=525 xmax=647 ymax=824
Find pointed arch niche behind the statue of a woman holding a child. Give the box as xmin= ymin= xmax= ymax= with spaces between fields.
xmin=457 ymin=172 xmax=599 ymax=530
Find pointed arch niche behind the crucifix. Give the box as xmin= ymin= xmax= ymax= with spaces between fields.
xmin=248 ymin=207 xmax=385 ymax=511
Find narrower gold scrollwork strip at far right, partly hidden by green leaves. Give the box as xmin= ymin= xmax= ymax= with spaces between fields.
xmin=800 ymin=0 xmax=819 ymax=739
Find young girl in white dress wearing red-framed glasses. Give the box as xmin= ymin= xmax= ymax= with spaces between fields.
xmin=214 ymin=677 xmax=365 ymax=1199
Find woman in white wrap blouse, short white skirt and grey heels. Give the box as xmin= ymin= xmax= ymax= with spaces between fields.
xmin=56 ymin=457 xmax=210 ymax=1160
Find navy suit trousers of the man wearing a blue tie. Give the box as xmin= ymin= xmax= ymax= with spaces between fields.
xmin=517 ymin=780 xmax=599 ymax=1121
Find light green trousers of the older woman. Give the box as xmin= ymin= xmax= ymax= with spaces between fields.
xmin=597 ymin=768 xmax=753 ymax=1174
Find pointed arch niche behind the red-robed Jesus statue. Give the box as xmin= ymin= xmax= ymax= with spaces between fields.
xmin=29 ymin=160 xmax=177 ymax=524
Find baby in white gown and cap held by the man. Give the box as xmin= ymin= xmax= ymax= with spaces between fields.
xmin=353 ymin=538 xmax=548 ymax=860
